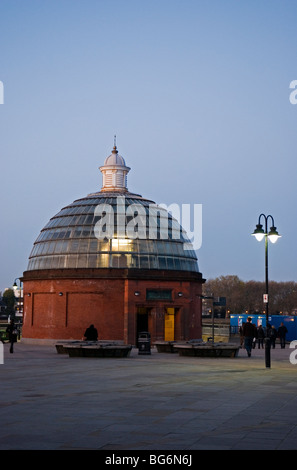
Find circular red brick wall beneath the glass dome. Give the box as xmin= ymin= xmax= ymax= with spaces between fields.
xmin=23 ymin=272 xmax=202 ymax=344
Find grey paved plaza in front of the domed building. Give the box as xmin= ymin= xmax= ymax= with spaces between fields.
xmin=0 ymin=342 xmax=297 ymax=451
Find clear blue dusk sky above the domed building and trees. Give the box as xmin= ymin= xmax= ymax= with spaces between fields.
xmin=0 ymin=0 xmax=297 ymax=291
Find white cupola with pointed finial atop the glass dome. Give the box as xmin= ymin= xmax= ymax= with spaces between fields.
xmin=99 ymin=139 xmax=130 ymax=192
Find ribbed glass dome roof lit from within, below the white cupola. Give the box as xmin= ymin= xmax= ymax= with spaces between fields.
xmin=27 ymin=191 xmax=199 ymax=272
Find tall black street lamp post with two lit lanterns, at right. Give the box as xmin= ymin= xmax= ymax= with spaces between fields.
xmin=252 ymin=214 xmax=281 ymax=367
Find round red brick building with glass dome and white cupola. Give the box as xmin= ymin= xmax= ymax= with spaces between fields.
xmin=22 ymin=141 xmax=204 ymax=344
